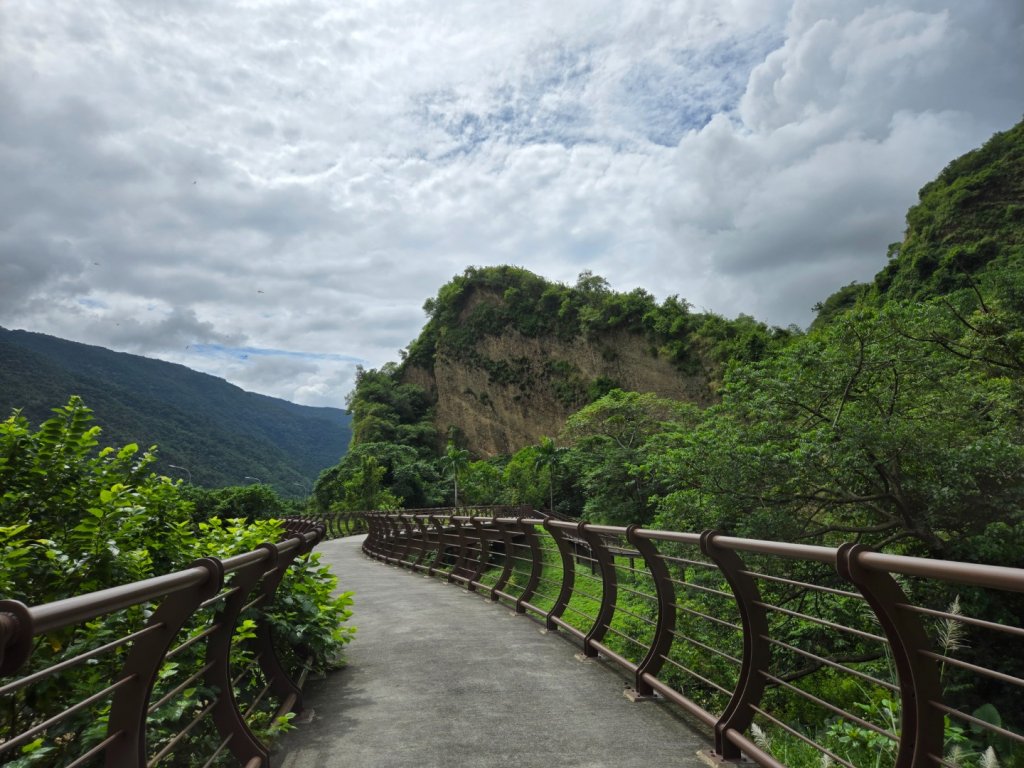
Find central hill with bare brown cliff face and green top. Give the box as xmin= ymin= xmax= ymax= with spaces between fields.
xmin=352 ymin=266 xmax=791 ymax=456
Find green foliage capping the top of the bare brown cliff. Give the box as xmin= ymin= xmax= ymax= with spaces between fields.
xmin=404 ymin=266 xmax=793 ymax=393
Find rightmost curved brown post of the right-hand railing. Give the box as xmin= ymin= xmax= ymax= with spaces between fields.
xmin=836 ymin=544 xmax=945 ymax=768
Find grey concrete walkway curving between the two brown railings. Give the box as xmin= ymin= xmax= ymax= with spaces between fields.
xmin=272 ymin=537 xmax=710 ymax=768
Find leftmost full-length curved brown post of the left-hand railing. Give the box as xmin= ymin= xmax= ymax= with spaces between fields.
xmin=104 ymin=557 xmax=224 ymax=768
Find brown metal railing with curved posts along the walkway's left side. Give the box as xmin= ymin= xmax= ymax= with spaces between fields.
xmin=0 ymin=518 xmax=327 ymax=768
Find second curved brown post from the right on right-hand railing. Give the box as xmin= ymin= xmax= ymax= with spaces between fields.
xmin=700 ymin=530 xmax=771 ymax=760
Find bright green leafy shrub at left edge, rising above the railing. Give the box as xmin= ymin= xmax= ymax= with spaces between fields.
xmin=0 ymin=396 xmax=188 ymax=602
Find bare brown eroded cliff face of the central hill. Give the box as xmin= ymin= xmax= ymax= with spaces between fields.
xmin=403 ymin=331 xmax=714 ymax=457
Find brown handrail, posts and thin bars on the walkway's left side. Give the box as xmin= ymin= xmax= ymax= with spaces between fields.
xmin=0 ymin=518 xmax=325 ymax=768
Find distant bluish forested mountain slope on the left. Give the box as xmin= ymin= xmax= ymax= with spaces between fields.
xmin=0 ymin=329 xmax=350 ymax=496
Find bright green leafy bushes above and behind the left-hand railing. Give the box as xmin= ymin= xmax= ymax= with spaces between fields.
xmin=0 ymin=397 xmax=352 ymax=766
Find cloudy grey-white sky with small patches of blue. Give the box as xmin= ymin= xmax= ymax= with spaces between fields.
xmin=0 ymin=0 xmax=1024 ymax=407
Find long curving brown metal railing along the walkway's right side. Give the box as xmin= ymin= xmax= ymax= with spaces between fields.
xmin=364 ymin=509 xmax=1024 ymax=768
